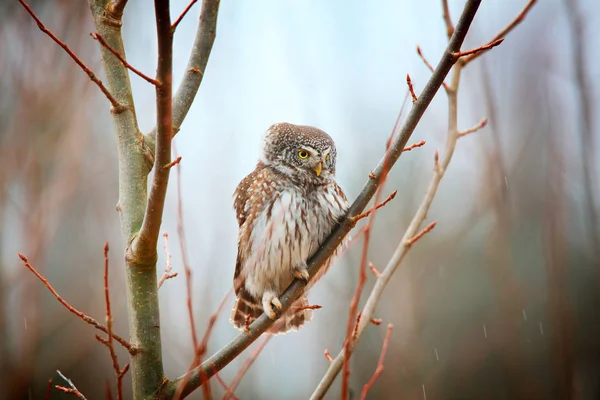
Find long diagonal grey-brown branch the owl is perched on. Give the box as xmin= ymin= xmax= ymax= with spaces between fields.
xmin=158 ymin=0 xmax=481 ymax=399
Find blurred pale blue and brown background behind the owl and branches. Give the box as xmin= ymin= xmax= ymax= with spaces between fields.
xmin=0 ymin=0 xmax=600 ymax=400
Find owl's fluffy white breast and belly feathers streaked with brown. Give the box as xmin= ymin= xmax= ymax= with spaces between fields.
xmin=239 ymin=177 xmax=347 ymax=297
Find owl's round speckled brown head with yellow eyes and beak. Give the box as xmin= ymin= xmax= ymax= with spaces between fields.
xmin=261 ymin=122 xmax=336 ymax=181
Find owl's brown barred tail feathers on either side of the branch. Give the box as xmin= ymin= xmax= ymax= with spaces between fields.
xmin=230 ymin=289 xmax=312 ymax=334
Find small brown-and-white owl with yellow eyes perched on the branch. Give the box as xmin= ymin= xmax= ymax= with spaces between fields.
xmin=231 ymin=123 xmax=348 ymax=333
